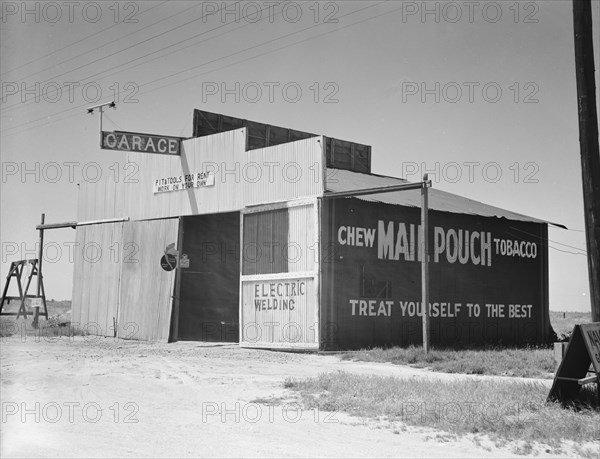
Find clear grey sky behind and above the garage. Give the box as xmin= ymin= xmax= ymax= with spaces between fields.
xmin=0 ymin=0 xmax=600 ymax=311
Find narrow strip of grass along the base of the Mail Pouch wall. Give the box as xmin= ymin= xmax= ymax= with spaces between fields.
xmin=341 ymin=346 xmax=554 ymax=378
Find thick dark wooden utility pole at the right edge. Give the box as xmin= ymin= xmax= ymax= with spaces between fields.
xmin=573 ymin=0 xmax=600 ymax=322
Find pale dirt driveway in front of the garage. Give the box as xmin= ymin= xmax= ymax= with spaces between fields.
xmin=1 ymin=336 xmax=568 ymax=458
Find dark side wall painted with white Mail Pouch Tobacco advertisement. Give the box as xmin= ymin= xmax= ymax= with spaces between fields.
xmin=322 ymin=199 xmax=549 ymax=348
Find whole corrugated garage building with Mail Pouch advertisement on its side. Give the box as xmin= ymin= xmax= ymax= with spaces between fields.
xmin=72 ymin=110 xmax=551 ymax=350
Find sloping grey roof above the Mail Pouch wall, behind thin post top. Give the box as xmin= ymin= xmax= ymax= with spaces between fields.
xmin=326 ymin=168 xmax=567 ymax=229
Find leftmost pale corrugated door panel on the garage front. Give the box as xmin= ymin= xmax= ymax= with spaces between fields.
xmin=71 ymin=223 xmax=123 ymax=336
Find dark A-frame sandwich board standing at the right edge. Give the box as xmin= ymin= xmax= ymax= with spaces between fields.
xmin=548 ymin=322 xmax=600 ymax=403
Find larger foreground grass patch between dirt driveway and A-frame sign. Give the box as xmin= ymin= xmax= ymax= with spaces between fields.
xmin=284 ymin=372 xmax=600 ymax=457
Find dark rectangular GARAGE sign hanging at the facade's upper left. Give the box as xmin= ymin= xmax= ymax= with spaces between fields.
xmin=102 ymin=131 xmax=181 ymax=155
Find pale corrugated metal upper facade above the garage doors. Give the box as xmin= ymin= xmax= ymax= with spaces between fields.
xmin=77 ymin=128 xmax=323 ymax=221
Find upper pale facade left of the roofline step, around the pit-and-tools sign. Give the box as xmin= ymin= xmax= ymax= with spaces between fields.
xmin=77 ymin=129 xmax=246 ymax=221
